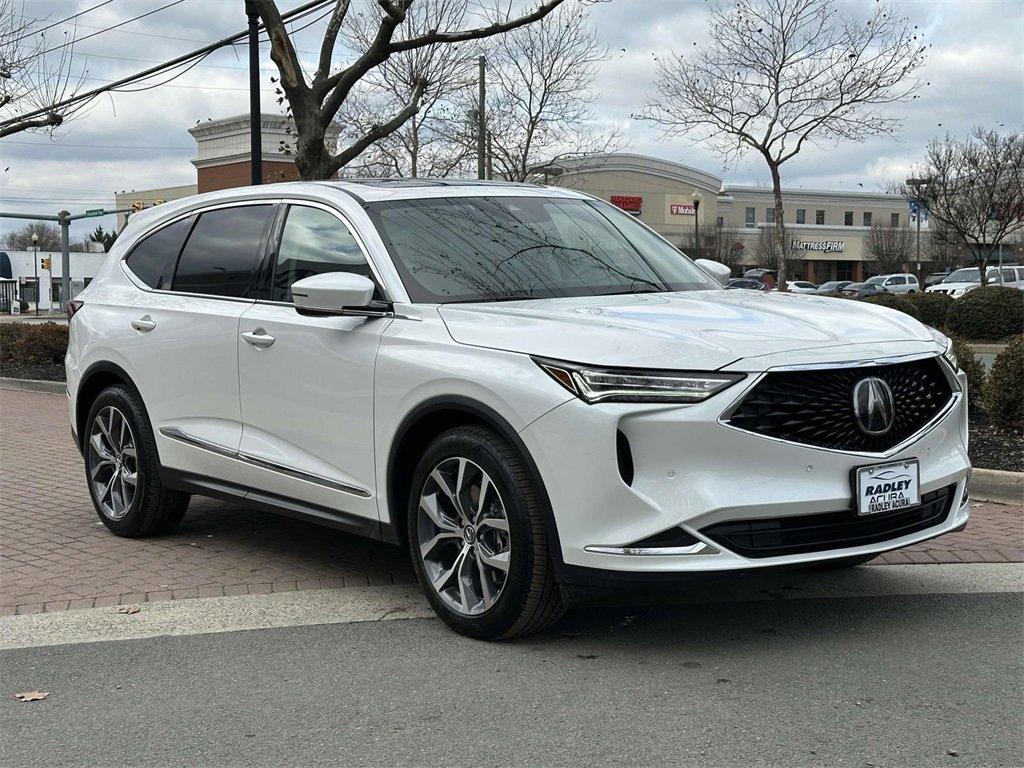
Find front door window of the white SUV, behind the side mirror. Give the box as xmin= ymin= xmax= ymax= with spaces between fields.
xmin=270 ymin=206 xmax=373 ymax=301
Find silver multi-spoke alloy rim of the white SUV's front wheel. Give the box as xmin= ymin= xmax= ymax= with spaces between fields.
xmin=418 ymin=457 xmax=512 ymax=615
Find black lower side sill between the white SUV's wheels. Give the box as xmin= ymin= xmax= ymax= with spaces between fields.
xmin=160 ymin=467 xmax=386 ymax=541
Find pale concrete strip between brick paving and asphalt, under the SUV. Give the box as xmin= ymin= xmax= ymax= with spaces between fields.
xmin=0 ymin=563 xmax=1024 ymax=649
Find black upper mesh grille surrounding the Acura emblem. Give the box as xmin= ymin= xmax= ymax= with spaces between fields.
xmin=728 ymin=357 xmax=952 ymax=453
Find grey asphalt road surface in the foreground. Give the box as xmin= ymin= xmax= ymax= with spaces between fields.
xmin=0 ymin=589 xmax=1024 ymax=767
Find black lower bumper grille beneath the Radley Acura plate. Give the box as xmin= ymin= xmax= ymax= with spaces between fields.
xmin=700 ymin=484 xmax=956 ymax=558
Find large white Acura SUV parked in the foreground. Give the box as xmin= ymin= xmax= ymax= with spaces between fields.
xmin=67 ymin=180 xmax=970 ymax=638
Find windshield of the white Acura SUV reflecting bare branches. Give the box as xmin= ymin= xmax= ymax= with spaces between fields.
xmin=367 ymin=197 xmax=721 ymax=303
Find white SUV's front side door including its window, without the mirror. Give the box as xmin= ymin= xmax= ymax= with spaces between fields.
xmin=238 ymin=204 xmax=390 ymax=527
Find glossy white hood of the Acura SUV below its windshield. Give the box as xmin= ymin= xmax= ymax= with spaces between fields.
xmin=438 ymin=290 xmax=935 ymax=371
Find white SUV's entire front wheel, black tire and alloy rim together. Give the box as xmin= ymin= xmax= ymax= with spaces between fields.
xmin=407 ymin=426 xmax=562 ymax=640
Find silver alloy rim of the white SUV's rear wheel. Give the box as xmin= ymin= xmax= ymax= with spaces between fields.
xmin=89 ymin=406 xmax=138 ymax=520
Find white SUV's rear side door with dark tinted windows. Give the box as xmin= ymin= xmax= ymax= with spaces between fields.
xmin=124 ymin=204 xmax=274 ymax=482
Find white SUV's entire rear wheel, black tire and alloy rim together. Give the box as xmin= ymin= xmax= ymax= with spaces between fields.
xmin=83 ymin=384 xmax=189 ymax=539
